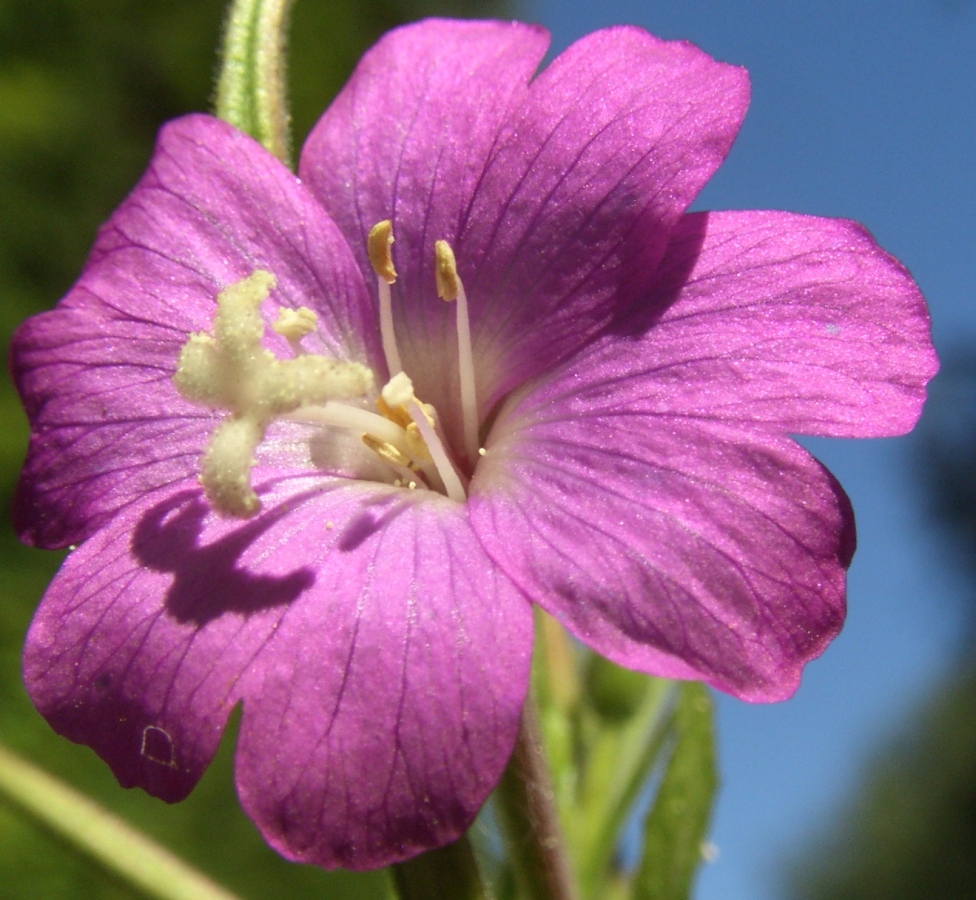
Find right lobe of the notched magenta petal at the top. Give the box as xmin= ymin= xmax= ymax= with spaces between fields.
xmin=455 ymin=27 xmax=749 ymax=399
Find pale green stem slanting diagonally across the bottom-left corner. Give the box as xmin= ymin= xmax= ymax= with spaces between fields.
xmin=0 ymin=747 xmax=236 ymax=900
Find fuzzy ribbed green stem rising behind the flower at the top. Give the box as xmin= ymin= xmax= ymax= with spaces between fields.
xmin=214 ymin=0 xmax=292 ymax=163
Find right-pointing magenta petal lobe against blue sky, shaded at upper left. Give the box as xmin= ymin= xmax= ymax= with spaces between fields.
xmin=564 ymin=212 xmax=938 ymax=437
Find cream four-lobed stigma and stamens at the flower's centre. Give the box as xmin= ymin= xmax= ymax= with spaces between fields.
xmin=173 ymin=221 xmax=482 ymax=518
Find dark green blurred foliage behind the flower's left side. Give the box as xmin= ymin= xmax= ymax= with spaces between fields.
xmin=0 ymin=0 xmax=506 ymax=900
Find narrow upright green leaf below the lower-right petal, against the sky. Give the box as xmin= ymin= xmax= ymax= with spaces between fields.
xmin=634 ymin=682 xmax=718 ymax=900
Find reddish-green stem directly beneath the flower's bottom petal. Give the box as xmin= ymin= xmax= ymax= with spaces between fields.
xmin=495 ymin=691 xmax=578 ymax=900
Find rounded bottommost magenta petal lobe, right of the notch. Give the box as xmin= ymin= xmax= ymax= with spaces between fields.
xmin=238 ymin=491 xmax=532 ymax=869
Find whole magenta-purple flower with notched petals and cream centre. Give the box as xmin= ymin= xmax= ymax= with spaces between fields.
xmin=13 ymin=15 xmax=936 ymax=868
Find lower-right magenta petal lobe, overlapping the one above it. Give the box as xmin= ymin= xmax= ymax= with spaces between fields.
xmin=471 ymin=414 xmax=854 ymax=701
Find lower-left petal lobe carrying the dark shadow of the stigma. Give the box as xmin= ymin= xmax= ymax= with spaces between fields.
xmin=24 ymin=481 xmax=282 ymax=802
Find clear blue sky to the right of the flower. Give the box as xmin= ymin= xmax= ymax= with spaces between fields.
xmin=519 ymin=0 xmax=976 ymax=900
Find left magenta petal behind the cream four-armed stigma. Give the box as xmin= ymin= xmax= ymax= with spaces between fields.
xmin=11 ymin=116 xmax=381 ymax=547
